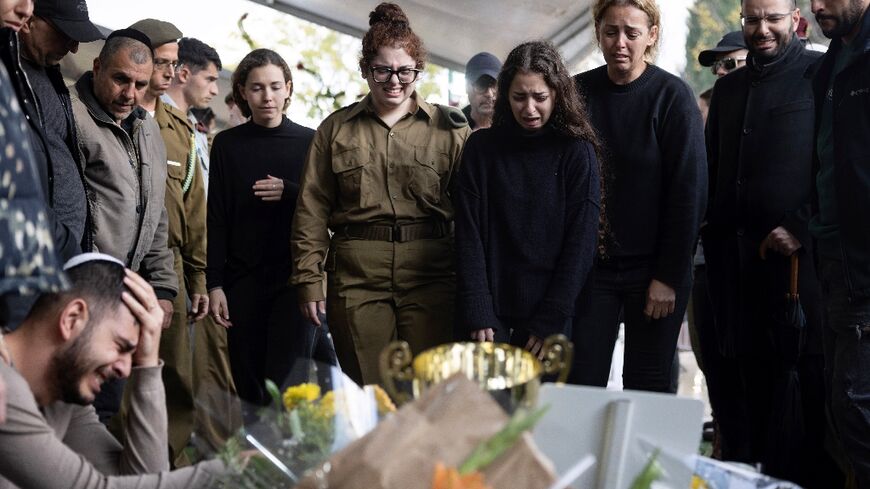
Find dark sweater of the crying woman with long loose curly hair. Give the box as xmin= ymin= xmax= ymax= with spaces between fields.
xmin=454 ymin=127 xmax=600 ymax=338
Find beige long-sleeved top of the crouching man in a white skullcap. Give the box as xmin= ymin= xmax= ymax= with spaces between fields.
xmin=0 ymin=361 xmax=224 ymax=489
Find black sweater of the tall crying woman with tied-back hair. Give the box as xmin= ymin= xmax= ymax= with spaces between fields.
xmin=575 ymin=65 xmax=707 ymax=287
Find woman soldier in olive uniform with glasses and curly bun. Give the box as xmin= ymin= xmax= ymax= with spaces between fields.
xmin=292 ymin=3 xmax=471 ymax=384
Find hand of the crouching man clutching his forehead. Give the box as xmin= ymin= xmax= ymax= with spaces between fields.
xmin=121 ymin=270 xmax=166 ymax=367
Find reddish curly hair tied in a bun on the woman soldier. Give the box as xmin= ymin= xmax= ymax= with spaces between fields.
xmin=359 ymin=2 xmax=429 ymax=71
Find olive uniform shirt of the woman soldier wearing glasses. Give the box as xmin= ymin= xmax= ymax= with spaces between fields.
xmin=291 ymin=94 xmax=471 ymax=303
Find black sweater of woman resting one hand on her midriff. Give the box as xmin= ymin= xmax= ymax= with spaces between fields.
xmin=206 ymin=118 xmax=314 ymax=290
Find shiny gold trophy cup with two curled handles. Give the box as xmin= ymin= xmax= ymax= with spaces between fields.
xmin=380 ymin=335 xmax=574 ymax=412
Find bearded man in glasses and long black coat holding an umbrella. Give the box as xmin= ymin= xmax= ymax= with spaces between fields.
xmin=703 ymin=0 xmax=838 ymax=487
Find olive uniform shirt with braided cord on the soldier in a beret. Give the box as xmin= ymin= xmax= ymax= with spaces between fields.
xmin=154 ymin=95 xmax=206 ymax=294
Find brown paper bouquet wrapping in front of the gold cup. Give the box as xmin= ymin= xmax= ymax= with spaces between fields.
xmin=297 ymin=374 xmax=555 ymax=489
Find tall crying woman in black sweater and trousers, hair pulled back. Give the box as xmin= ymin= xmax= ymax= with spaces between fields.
xmin=571 ymin=0 xmax=707 ymax=391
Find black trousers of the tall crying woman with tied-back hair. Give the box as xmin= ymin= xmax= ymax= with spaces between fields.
xmin=569 ymin=258 xmax=690 ymax=392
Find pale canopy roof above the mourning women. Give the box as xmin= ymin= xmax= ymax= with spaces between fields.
xmin=245 ymin=0 xmax=595 ymax=71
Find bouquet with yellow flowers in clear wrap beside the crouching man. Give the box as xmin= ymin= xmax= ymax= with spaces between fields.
xmin=216 ymin=367 xmax=396 ymax=489
